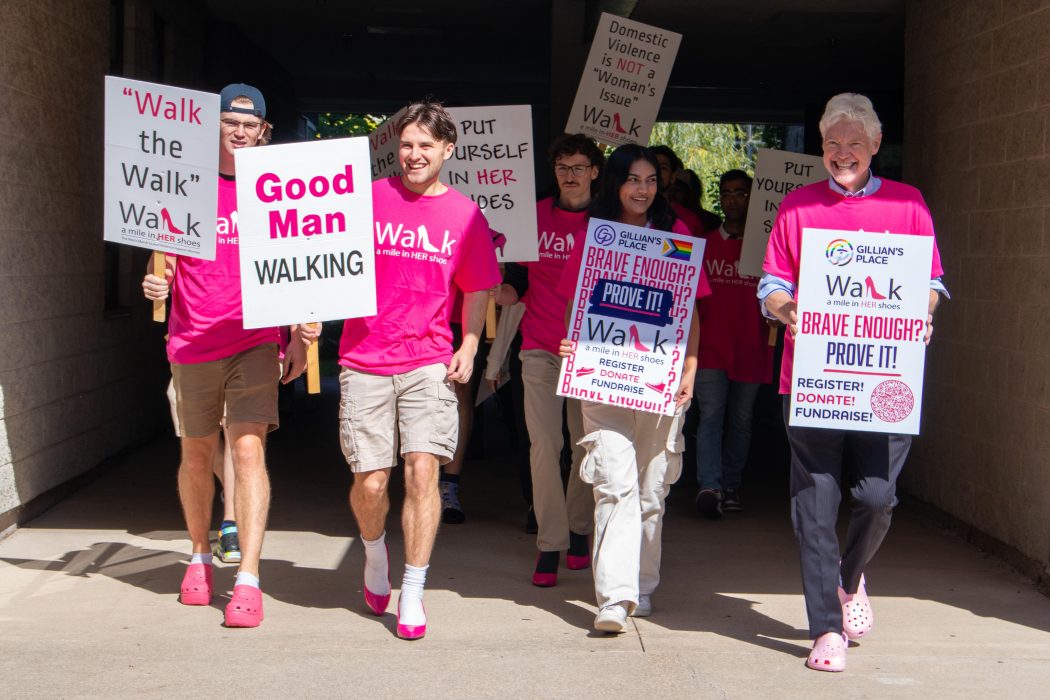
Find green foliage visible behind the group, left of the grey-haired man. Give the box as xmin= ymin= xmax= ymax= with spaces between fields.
xmin=649 ymin=122 xmax=784 ymax=214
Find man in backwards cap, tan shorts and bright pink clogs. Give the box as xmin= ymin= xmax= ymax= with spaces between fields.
xmin=142 ymin=83 xmax=306 ymax=628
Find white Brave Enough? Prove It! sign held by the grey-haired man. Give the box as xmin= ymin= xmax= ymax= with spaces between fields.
xmin=789 ymin=229 xmax=933 ymax=434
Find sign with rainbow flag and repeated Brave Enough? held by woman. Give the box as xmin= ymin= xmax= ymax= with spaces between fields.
xmin=558 ymin=218 xmax=705 ymax=416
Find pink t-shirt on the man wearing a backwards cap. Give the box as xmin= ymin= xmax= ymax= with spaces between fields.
xmin=168 ymin=177 xmax=280 ymax=364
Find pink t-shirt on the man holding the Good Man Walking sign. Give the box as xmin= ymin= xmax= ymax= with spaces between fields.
xmin=339 ymin=176 xmax=500 ymax=376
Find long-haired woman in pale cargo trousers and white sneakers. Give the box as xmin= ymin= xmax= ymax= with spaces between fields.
xmin=558 ymin=144 xmax=711 ymax=633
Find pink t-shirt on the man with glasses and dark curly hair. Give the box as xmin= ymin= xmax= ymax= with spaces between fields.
xmin=521 ymin=197 xmax=590 ymax=355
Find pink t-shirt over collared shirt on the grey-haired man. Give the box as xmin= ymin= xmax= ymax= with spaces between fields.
xmin=762 ymin=178 xmax=944 ymax=394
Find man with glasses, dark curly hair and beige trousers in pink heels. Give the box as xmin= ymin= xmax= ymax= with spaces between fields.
xmin=498 ymin=133 xmax=605 ymax=588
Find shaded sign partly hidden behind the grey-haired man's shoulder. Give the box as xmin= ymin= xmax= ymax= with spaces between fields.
xmin=740 ymin=148 xmax=827 ymax=277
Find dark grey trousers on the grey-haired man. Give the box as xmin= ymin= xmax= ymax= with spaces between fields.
xmin=783 ymin=396 xmax=911 ymax=639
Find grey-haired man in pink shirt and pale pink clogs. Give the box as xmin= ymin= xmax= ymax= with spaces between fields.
xmin=758 ymin=92 xmax=947 ymax=671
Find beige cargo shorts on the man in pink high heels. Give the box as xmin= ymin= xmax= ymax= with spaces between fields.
xmin=339 ymin=363 xmax=459 ymax=472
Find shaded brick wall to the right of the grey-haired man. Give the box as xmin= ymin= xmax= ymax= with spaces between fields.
xmin=904 ymin=0 xmax=1050 ymax=575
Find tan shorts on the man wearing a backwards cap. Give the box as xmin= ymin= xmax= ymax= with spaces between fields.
xmin=171 ymin=343 xmax=280 ymax=438
